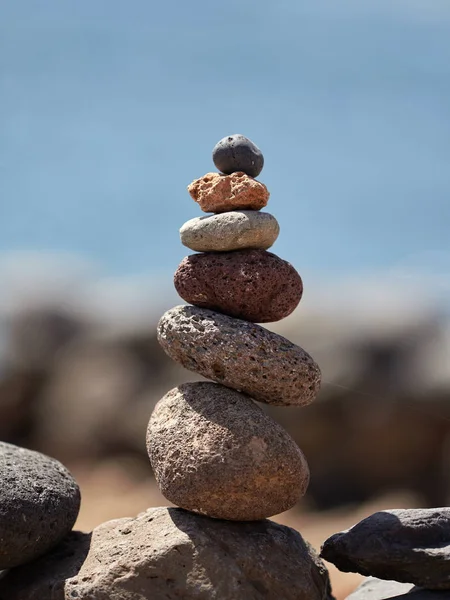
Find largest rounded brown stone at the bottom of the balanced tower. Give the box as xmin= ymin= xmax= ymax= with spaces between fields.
xmin=147 ymin=382 xmax=309 ymax=521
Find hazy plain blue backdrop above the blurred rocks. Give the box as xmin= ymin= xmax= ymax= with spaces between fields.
xmin=0 ymin=0 xmax=450 ymax=275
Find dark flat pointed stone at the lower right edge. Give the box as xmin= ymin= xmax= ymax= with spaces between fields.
xmin=321 ymin=508 xmax=450 ymax=590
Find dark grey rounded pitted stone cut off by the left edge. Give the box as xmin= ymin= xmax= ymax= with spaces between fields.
xmin=0 ymin=442 xmax=80 ymax=569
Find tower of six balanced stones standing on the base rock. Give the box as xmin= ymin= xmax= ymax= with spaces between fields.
xmin=147 ymin=135 xmax=320 ymax=521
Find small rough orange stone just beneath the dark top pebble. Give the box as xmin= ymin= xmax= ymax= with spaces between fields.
xmin=188 ymin=172 xmax=270 ymax=213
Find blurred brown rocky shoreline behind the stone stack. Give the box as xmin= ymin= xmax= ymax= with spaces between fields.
xmin=0 ymin=258 xmax=450 ymax=509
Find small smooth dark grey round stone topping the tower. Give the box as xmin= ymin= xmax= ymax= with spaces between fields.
xmin=213 ymin=133 xmax=264 ymax=177
